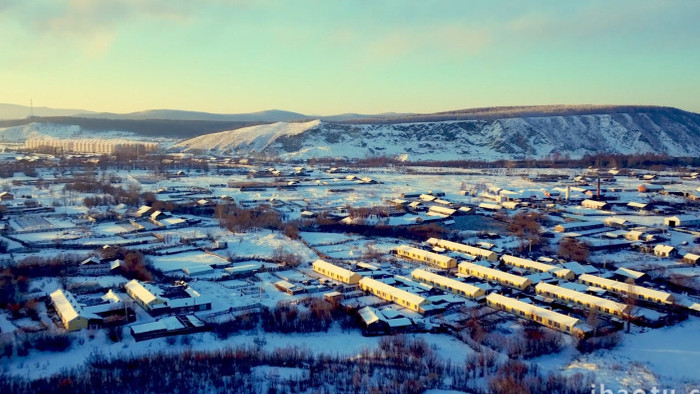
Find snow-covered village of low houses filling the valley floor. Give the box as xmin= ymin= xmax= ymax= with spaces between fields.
xmin=0 ymin=152 xmax=700 ymax=390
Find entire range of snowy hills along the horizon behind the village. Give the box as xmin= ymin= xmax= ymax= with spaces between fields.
xmin=0 ymin=105 xmax=700 ymax=160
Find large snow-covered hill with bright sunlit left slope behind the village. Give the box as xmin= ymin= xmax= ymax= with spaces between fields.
xmin=174 ymin=107 xmax=700 ymax=160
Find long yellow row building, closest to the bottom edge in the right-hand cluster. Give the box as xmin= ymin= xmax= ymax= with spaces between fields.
xmin=486 ymin=293 xmax=588 ymax=337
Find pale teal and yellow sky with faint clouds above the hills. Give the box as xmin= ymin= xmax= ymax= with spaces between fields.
xmin=0 ymin=0 xmax=700 ymax=115
